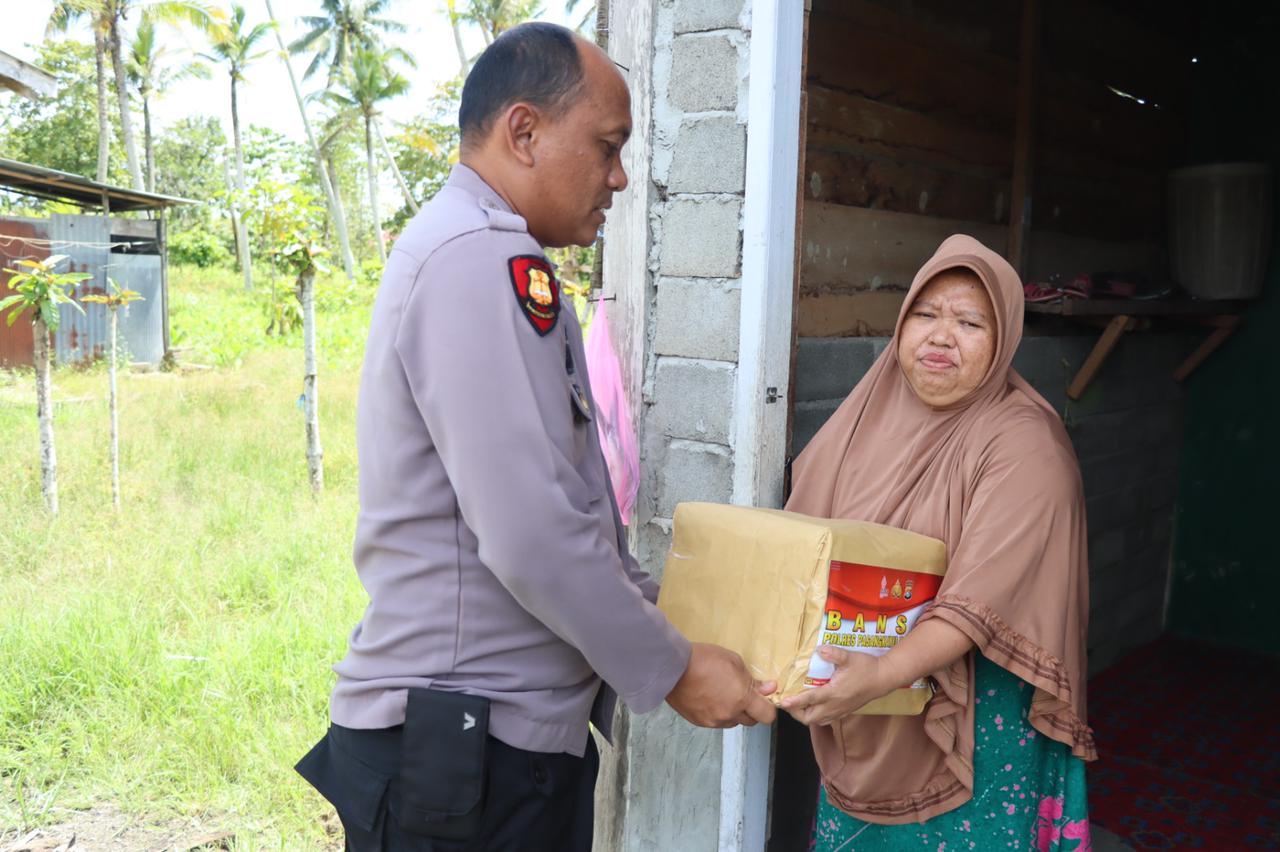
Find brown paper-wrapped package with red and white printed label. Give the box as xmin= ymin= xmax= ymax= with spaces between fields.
xmin=658 ymin=503 xmax=947 ymax=714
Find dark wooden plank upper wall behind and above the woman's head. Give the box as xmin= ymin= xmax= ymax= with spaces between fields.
xmin=797 ymin=0 xmax=1192 ymax=336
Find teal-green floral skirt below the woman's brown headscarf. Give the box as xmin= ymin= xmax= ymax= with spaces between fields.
xmin=810 ymin=654 xmax=1092 ymax=852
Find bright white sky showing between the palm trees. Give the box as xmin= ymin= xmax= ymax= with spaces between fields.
xmin=0 ymin=0 xmax=585 ymax=141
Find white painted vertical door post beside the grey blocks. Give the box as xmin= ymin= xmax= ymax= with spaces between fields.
xmin=719 ymin=0 xmax=804 ymax=852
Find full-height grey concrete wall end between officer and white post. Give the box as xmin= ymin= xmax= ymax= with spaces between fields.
xmin=595 ymin=0 xmax=750 ymax=852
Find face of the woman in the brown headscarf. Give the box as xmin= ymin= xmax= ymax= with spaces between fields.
xmin=897 ymin=269 xmax=996 ymax=408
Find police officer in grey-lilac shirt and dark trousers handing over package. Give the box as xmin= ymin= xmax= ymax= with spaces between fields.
xmin=298 ymin=23 xmax=774 ymax=852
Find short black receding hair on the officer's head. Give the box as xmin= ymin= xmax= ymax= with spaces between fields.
xmin=458 ymin=22 xmax=584 ymax=145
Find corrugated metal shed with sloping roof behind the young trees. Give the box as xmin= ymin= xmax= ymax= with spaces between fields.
xmin=0 ymin=159 xmax=196 ymax=367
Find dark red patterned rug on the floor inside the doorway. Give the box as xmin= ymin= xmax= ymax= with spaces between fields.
xmin=1089 ymin=637 xmax=1280 ymax=852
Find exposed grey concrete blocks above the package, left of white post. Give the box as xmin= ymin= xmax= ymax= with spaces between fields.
xmin=636 ymin=0 xmax=750 ymax=573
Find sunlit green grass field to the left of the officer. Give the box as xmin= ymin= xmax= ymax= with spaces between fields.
xmin=0 ymin=263 xmax=371 ymax=849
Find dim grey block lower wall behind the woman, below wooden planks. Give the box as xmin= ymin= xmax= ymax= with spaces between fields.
xmin=792 ymin=334 xmax=1196 ymax=672
